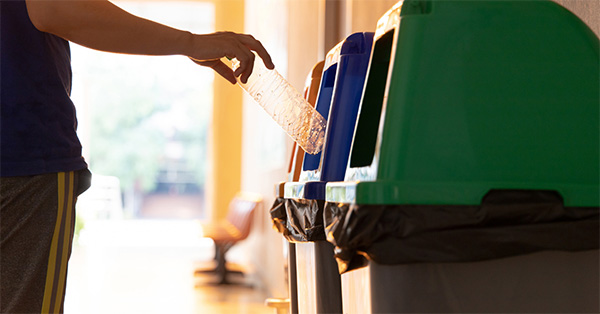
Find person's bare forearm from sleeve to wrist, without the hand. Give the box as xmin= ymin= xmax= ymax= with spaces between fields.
xmin=27 ymin=0 xmax=193 ymax=55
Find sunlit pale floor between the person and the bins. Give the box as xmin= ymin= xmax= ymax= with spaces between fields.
xmin=65 ymin=220 xmax=275 ymax=314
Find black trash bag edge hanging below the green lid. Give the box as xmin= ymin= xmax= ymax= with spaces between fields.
xmin=324 ymin=190 xmax=600 ymax=273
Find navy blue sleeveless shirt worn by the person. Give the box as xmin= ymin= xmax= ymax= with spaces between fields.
xmin=0 ymin=0 xmax=87 ymax=177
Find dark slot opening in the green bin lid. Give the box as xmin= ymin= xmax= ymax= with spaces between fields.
xmin=350 ymin=29 xmax=394 ymax=168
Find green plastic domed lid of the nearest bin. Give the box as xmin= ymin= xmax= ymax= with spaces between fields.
xmin=327 ymin=0 xmax=600 ymax=206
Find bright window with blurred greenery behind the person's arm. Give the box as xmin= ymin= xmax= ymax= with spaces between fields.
xmin=71 ymin=1 xmax=214 ymax=216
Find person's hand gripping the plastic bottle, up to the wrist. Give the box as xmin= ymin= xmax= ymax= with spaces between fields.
xmin=189 ymin=32 xmax=275 ymax=84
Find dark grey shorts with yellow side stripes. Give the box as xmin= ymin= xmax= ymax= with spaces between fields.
xmin=0 ymin=170 xmax=91 ymax=314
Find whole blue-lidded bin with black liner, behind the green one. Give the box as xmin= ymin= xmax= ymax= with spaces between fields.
xmin=284 ymin=32 xmax=374 ymax=313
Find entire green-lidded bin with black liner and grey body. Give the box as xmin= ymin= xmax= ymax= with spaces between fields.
xmin=325 ymin=1 xmax=600 ymax=313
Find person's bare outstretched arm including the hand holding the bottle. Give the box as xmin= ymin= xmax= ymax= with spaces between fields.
xmin=26 ymin=0 xmax=274 ymax=84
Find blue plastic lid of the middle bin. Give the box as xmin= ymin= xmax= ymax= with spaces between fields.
xmin=301 ymin=32 xmax=374 ymax=199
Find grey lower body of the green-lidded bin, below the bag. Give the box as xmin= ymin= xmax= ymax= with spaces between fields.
xmin=370 ymin=250 xmax=600 ymax=313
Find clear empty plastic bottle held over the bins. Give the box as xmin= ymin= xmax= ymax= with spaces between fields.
xmin=232 ymin=56 xmax=327 ymax=154
